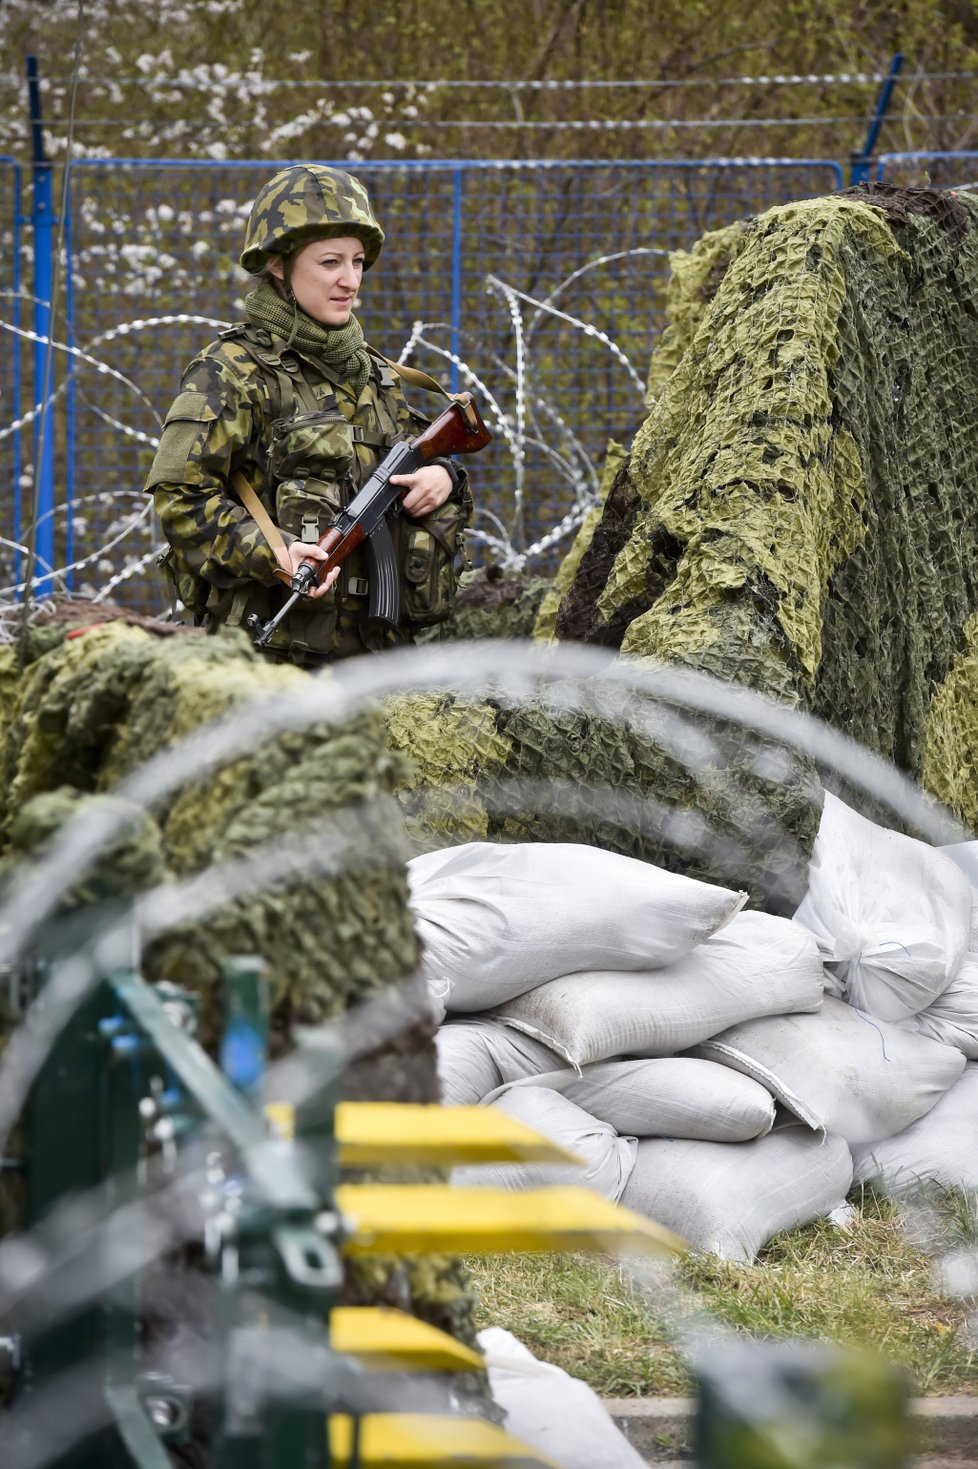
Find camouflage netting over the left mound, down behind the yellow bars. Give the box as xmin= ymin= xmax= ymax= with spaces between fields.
xmin=0 ymin=610 xmax=484 ymax=1380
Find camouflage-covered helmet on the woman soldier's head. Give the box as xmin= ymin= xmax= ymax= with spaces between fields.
xmin=241 ymin=163 xmax=383 ymax=275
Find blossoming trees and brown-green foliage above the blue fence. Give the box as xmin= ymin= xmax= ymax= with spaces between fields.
xmin=0 ymin=0 xmax=978 ymax=163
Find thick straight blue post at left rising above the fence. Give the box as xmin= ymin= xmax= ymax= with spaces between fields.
xmin=26 ymin=56 xmax=56 ymax=595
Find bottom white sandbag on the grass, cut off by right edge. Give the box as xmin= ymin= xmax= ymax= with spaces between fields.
xmin=853 ymin=1064 xmax=978 ymax=1193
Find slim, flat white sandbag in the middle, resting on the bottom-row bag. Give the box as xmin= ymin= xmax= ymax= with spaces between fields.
xmin=486 ymin=1056 xmax=774 ymax=1143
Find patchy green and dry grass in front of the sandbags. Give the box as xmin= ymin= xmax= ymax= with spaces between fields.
xmin=468 ymin=1190 xmax=978 ymax=1397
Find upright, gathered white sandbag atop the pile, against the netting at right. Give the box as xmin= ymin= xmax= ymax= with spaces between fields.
xmin=794 ymin=792 xmax=971 ymax=1019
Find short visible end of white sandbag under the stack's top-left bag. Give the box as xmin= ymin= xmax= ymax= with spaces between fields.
xmin=435 ymin=1019 xmax=561 ymax=1106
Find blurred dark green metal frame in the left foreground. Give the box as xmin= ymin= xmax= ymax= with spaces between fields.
xmin=18 ymin=914 xmax=352 ymax=1469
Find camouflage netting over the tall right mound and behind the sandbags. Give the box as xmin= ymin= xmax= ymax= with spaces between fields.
xmin=393 ymin=185 xmax=978 ymax=881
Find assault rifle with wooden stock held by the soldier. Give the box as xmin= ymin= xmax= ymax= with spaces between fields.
xmin=245 ymin=392 xmax=492 ymax=648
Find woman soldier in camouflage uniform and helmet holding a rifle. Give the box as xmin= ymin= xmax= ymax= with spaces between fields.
xmin=145 ymin=165 xmax=470 ymax=667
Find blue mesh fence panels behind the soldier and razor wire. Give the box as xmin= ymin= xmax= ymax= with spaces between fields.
xmin=51 ymin=151 xmax=978 ymax=605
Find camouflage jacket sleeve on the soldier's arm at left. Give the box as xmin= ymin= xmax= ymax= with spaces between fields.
xmin=145 ymin=342 xmax=287 ymax=591
